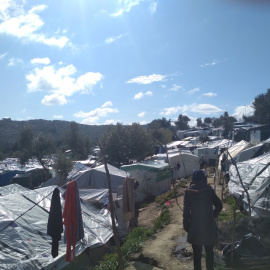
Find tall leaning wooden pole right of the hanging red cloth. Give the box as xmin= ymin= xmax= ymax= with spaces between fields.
xmin=97 ymin=140 xmax=124 ymax=270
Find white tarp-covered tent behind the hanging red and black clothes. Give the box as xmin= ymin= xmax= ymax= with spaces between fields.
xmin=0 ymin=184 xmax=113 ymax=270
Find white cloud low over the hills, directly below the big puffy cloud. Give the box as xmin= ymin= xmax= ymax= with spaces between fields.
xmin=73 ymin=101 xmax=119 ymax=125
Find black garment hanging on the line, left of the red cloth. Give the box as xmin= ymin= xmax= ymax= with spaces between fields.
xmin=47 ymin=188 xmax=63 ymax=258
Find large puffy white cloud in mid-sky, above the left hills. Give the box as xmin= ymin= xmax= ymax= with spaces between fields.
xmin=26 ymin=65 xmax=103 ymax=105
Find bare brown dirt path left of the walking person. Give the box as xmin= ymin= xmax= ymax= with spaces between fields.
xmin=127 ymin=169 xmax=224 ymax=270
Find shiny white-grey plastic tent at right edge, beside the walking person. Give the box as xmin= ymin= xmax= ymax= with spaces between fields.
xmin=228 ymin=152 xmax=270 ymax=216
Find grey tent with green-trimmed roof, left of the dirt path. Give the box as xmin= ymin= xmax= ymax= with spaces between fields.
xmin=121 ymin=160 xmax=172 ymax=202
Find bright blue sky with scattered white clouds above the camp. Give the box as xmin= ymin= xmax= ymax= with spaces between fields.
xmin=0 ymin=0 xmax=270 ymax=125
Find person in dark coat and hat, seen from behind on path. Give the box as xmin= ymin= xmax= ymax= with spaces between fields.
xmin=183 ymin=170 xmax=223 ymax=270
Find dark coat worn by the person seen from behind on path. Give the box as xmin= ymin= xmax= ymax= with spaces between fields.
xmin=183 ymin=185 xmax=223 ymax=245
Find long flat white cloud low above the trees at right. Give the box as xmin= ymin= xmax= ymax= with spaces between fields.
xmin=160 ymin=103 xmax=223 ymax=116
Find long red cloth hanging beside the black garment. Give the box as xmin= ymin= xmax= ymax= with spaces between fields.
xmin=63 ymin=180 xmax=77 ymax=262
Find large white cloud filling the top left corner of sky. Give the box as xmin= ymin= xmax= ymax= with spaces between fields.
xmin=0 ymin=0 xmax=71 ymax=48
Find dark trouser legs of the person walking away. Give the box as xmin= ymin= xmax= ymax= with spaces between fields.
xmin=192 ymin=245 xmax=214 ymax=270
